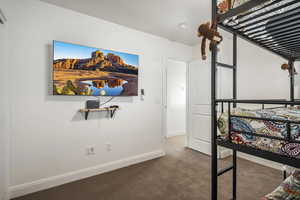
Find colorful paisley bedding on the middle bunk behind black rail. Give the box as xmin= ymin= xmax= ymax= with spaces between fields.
xmin=218 ymin=108 xmax=300 ymax=158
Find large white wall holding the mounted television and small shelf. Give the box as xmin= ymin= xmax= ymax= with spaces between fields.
xmin=1 ymin=0 xmax=192 ymax=196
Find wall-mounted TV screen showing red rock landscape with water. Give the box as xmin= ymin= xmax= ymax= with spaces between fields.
xmin=53 ymin=41 xmax=139 ymax=96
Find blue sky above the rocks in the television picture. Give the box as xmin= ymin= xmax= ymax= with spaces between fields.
xmin=53 ymin=41 xmax=139 ymax=67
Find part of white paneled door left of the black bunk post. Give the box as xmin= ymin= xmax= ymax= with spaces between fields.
xmin=188 ymin=60 xmax=211 ymax=155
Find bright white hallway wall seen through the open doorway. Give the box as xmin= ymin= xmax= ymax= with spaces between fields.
xmin=166 ymin=59 xmax=187 ymax=137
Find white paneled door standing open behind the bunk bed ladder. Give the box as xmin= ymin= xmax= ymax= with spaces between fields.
xmin=187 ymin=60 xmax=232 ymax=156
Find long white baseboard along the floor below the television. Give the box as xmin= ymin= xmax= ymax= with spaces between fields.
xmin=9 ymin=150 xmax=165 ymax=198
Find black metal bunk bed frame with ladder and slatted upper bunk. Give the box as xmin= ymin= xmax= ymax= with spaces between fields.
xmin=211 ymin=0 xmax=300 ymax=200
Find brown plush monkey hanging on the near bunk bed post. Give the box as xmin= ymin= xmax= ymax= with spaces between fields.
xmin=198 ymin=22 xmax=223 ymax=60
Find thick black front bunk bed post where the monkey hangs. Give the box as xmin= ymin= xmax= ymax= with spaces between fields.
xmin=211 ymin=0 xmax=218 ymax=200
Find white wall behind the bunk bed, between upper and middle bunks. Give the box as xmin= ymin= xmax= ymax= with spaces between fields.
xmin=193 ymin=31 xmax=290 ymax=99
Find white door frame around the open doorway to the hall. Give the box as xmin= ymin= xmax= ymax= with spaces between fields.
xmin=162 ymin=57 xmax=190 ymax=147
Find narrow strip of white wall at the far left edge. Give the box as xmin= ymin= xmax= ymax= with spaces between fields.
xmin=0 ymin=11 xmax=10 ymax=200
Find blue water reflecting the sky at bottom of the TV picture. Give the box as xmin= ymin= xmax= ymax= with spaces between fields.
xmin=81 ymin=81 xmax=128 ymax=96
